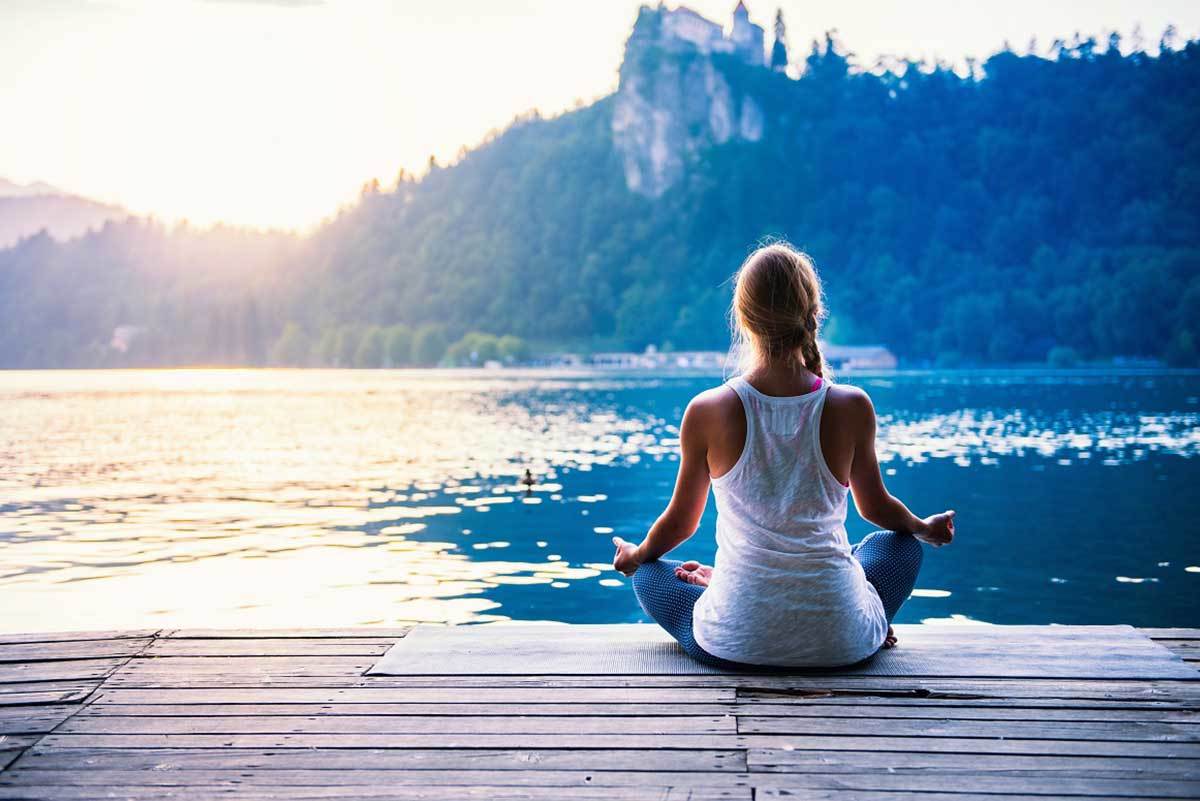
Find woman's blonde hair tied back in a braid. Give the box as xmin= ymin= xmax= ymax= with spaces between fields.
xmin=730 ymin=242 xmax=828 ymax=378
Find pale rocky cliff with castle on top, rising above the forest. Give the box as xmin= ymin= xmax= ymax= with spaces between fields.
xmin=612 ymin=7 xmax=764 ymax=198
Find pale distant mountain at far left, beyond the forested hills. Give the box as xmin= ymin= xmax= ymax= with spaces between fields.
xmin=0 ymin=177 xmax=128 ymax=247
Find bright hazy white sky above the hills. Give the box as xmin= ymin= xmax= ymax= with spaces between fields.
xmin=0 ymin=0 xmax=1200 ymax=227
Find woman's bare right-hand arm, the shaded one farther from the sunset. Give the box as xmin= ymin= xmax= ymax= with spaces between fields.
xmin=850 ymin=392 xmax=954 ymax=546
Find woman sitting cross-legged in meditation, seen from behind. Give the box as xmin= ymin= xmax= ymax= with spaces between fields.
xmin=613 ymin=243 xmax=954 ymax=667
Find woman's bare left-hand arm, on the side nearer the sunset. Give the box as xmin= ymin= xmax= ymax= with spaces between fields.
xmin=612 ymin=396 xmax=715 ymax=576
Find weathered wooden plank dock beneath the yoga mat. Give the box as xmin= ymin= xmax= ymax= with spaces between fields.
xmin=0 ymin=628 xmax=1200 ymax=801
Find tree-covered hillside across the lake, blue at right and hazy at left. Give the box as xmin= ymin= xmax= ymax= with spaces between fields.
xmin=0 ymin=29 xmax=1200 ymax=366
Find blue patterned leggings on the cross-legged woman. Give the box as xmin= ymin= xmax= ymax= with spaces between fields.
xmin=634 ymin=531 xmax=924 ymax=668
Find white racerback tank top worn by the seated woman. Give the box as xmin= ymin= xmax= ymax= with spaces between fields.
xmin=692 ymin=377 xmax=888 ymax=667
